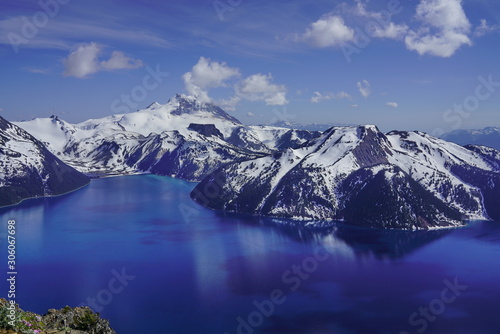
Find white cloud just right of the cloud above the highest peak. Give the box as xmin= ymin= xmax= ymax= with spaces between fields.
xmin=236 ymin=73 xmax=288 ymax=105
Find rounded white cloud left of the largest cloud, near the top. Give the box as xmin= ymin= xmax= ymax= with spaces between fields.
xmin=298 ymin=15 xmax=354 ymax=48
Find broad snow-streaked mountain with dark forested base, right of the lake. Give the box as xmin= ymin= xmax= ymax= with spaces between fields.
xmin=191 ymin=125 xmax=500 ymax=229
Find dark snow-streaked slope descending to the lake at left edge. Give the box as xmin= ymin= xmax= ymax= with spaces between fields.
xmin=0 ymin=117 xmax=90 ymax=206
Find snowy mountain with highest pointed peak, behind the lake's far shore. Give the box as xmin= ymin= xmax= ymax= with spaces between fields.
xmin=16 ymin=95 xmax=319 ymax=181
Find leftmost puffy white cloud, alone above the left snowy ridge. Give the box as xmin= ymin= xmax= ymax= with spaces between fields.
xmin=63 ymin=43 xmax=144 ymax=78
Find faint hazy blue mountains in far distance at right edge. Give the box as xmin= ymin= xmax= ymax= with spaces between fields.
xmin=441 ymin=127 xmax=500 ymax=150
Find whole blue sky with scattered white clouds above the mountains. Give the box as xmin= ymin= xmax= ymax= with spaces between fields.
xmin=0 ymin=0 xmax=500 ymax=135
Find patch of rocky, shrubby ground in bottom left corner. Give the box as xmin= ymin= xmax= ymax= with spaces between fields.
xmin=0 ymin=298 xmax=116 ymax=334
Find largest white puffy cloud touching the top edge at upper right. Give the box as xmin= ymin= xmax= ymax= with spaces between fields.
xmin=405 ymin=0 xmax=472 ymax=57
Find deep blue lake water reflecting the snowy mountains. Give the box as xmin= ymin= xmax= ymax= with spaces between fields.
xmin=0 ymin=175 xmax=500 ymax=334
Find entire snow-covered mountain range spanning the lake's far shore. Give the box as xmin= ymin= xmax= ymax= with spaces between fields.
xmin=0 ymin=95 xmax=500 ymax=229
